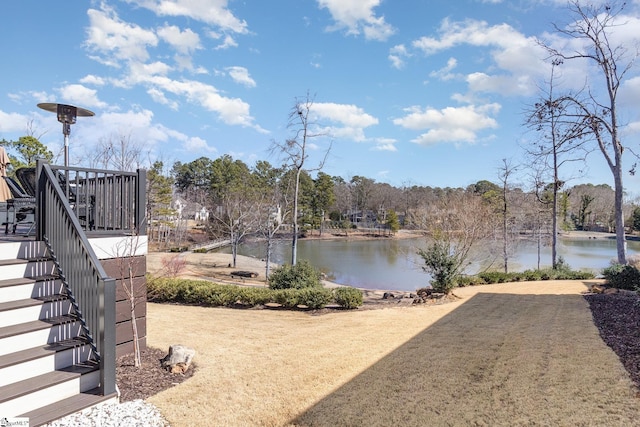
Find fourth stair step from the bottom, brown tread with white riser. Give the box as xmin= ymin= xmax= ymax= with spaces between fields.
xmin=0 ymin=315 xmax=80 ymax=356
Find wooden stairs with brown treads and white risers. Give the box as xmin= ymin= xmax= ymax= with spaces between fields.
xmin=0 ymin=242 xmax=117 ymax=427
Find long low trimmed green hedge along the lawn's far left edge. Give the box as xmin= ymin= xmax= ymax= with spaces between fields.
xmin=147 ymin=278 xmax=363 ymax=309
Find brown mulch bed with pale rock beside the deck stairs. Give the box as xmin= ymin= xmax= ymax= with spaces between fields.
xmin=116 ymin=347 xmax=196 ymax=402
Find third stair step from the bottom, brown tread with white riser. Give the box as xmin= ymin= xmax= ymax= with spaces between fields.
xmin=0 ymin=338 xmax=93 ymax=387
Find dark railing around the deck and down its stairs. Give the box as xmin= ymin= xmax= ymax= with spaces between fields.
xmin=35 ymin=161 xmax=145 ymax=395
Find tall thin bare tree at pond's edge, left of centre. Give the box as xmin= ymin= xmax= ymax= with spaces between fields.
xmin=271 ymin=93 xmax=331 ymax=265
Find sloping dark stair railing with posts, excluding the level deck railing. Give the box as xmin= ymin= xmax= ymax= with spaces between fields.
xmin=36 ymin=161 xmax=116 ymax=395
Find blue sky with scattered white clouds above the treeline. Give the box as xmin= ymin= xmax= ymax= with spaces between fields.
xmin=0 ymin=0 xmax=640 ymax=193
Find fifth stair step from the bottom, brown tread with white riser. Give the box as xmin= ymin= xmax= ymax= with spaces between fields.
xmin=0 ymin=295 xmax=71 ymax=326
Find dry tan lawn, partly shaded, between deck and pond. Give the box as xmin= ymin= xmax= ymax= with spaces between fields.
xmin=148 ymin=282 xmax=640 ymax=426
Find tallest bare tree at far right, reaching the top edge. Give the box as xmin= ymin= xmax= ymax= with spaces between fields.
xmin=542 ymin=0 xmax=639 ymax=264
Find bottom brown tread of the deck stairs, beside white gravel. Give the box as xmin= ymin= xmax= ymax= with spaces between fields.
xmin=19 ymin=388 xmax=118 ymax=427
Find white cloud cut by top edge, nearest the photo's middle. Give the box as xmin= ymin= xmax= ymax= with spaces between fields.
xmin=318 ymin=0 xmax=395 ymax=41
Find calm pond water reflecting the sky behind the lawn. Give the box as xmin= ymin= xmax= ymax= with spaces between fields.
xmin=216 ymin=238 xmax=640 ymax=291
